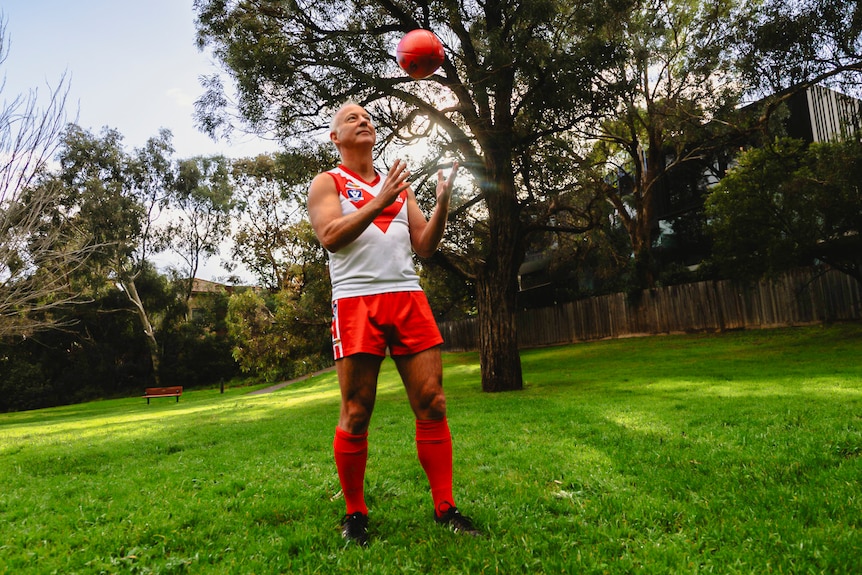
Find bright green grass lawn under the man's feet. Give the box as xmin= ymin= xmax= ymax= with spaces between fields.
xmin=0 ymin=324 xmax=862 ymax=574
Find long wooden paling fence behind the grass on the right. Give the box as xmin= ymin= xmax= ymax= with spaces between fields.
xmin=440 ymin=268 xmax=862 ymax=351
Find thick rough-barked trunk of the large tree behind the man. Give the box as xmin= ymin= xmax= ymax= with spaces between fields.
xmin=476 ymin=173 xmax=524 ymax=392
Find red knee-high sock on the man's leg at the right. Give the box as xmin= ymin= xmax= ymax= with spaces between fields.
xmin=416 ymin=417 xmax=455 ymax=517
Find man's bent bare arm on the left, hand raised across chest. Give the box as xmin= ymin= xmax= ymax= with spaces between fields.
xmin=308 ymin=160 xmax=414 ymax=252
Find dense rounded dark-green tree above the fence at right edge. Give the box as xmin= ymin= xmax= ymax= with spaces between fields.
xmin=707 ymin=139 xmax=862 ymax=283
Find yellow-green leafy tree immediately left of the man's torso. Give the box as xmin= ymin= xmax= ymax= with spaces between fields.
xmin=229 ymin=147 xmax=336 ymax=377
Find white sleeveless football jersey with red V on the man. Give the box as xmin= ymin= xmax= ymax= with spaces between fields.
xmin=327 ymin=166 xmax=421 ymax=299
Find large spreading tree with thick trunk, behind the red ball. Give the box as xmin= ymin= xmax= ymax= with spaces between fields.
xmin=195 ymin=0 xmax=629 ymax=391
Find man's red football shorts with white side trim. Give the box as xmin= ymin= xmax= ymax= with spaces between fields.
xmin=332 ymin=291 xmax=443 ymax=359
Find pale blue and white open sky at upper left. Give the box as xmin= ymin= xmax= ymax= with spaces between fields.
xmin=0 ymin=0 xmax=276 ymax=279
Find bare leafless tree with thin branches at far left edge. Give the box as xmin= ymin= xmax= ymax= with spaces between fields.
xmin=0 ymin=14 xmax=95 ymax=337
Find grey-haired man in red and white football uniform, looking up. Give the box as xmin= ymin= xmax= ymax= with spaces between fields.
xmin=308 ymin=102 xmax=478 ymax=546
